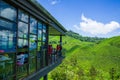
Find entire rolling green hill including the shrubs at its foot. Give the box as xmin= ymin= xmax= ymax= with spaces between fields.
xmin=49 ymin=36 xmax=120 ymax=80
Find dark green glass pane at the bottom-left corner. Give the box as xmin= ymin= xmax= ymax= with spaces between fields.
xmin=0 ymin=53 xmax=15 ymax=80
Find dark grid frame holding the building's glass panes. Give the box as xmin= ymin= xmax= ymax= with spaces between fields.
xmin=0 ymin=0 xmax=47 ymax=78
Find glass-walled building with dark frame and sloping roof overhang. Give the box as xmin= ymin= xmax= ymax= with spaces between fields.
xmin=0 ymin=0 xmax=66 ymax=80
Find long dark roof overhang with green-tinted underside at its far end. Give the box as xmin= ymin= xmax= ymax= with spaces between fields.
xmin=5 ymin=0 xmax=67 ymax=35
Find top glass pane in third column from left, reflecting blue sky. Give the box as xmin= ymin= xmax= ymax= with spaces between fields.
xmin=30 ymin=17 xmax=37 ymax=34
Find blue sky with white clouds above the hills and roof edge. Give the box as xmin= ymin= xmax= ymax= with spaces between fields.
xmin=37 ymin=0 xmax=120 ymax=37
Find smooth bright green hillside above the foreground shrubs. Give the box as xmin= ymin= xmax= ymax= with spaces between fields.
xmin=48 ymin=36 xmax=120 ymax=79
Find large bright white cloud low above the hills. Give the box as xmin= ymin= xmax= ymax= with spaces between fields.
xmin=74 ymin=15 xmax=120 ymax=35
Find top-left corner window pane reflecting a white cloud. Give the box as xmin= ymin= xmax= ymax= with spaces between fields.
xmin=0 ymin=1 xmax=17 ymax=21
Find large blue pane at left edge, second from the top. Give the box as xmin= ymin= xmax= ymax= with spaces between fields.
xmin=0 ymin=20 xmax=16 ymax=52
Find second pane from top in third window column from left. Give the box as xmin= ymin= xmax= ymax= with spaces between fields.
xmin=29 ymin=35 xmax=37 ymax=50
